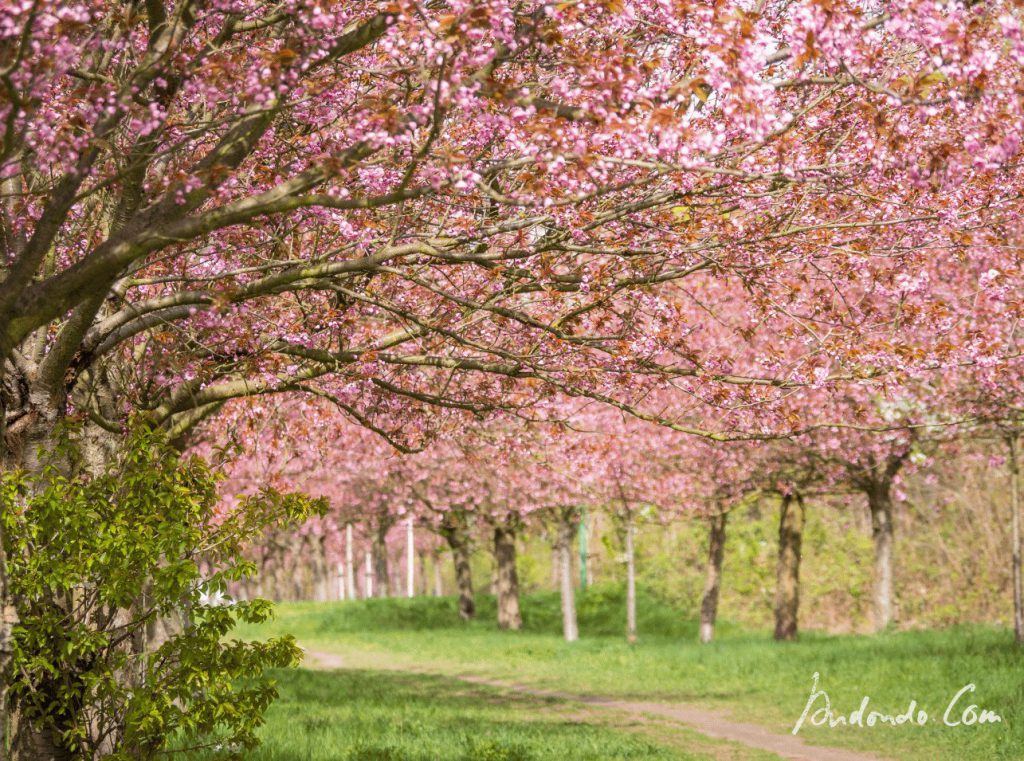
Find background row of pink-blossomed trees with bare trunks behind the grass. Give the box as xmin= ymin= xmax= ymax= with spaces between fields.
xmin=214 ymin=393 xmax=1024 ymax=642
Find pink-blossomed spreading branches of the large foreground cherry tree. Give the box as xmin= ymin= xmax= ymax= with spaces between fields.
xmin=0 ymin=0 xmax=1024 ymax=757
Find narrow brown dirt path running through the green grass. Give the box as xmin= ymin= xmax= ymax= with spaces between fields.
xmin=306 ymin=650 xmax=886 ymax=761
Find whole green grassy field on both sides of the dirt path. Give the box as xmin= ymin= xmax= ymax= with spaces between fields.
xmin=230 ymin=588 xmax=1024 ymax=761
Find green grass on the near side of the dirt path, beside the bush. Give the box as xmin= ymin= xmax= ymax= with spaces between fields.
xmin=186 ymin=669 xmax=777 ymax=761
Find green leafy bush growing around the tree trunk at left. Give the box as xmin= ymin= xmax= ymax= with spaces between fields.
xmin=0 ymin=430 xmax=323 ymax=760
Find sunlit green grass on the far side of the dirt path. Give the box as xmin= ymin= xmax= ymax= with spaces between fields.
xmin=234 ymin=588 xmax=1024 ymax=761
